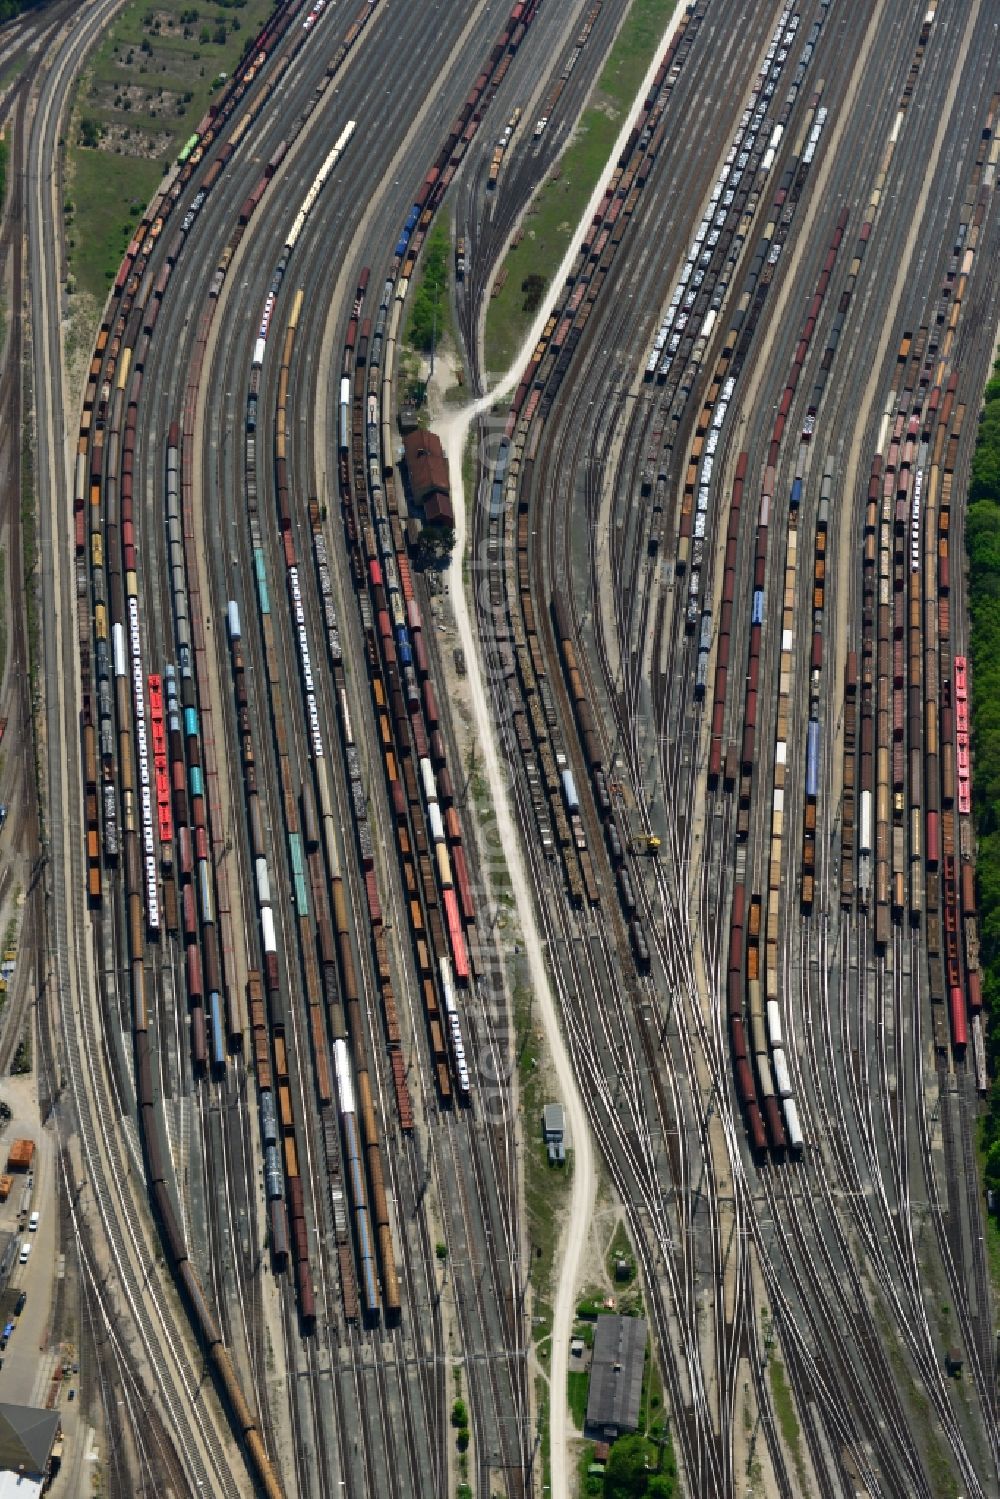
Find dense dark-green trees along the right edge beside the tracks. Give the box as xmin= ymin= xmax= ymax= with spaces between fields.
xmin=966 ymin=358 xmax=1000 ymax=1217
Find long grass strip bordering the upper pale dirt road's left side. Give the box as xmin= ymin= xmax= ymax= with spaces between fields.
xmin=486 ymin=0 xmax=675 ymax=375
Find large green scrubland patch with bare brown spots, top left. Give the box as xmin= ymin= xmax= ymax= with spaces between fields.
xmin=68 ymin=0 xmax=274 ymax=303
